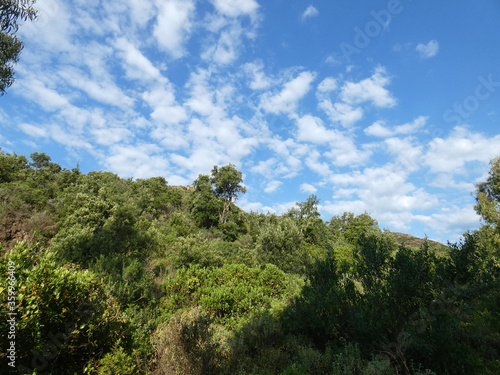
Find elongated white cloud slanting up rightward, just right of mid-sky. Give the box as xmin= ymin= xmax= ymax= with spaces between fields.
xmin=261 ymin=72 xmax=315 ymax=114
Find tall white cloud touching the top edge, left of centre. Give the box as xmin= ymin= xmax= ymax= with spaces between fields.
xmin=153 ymin=0 xmax=195 ymax=58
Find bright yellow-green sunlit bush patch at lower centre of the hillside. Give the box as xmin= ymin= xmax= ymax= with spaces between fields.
xmin=163 ymin=264 xmax=300 ymax=327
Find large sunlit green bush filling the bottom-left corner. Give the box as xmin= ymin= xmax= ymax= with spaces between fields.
xmin=0 ymin=242 xmax=126 ymax=374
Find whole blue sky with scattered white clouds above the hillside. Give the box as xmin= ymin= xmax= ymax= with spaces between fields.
xmin=0 ymin=0 xmax=500 ymax=243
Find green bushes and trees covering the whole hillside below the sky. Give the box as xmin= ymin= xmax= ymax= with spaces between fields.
xmin=0 ymin=152 xmax=500 ymax=375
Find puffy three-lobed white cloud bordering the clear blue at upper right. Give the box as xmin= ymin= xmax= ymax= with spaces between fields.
xmin=341 ymin=66 xmax=396 ymax=108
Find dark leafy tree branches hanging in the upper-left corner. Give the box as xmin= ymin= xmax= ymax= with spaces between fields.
xmin=0 ymin=0 xmax=37 ymax=95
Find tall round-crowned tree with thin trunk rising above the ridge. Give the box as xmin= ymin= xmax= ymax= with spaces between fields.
xmin=210 ymin=164 xmax=247 ymax=224
